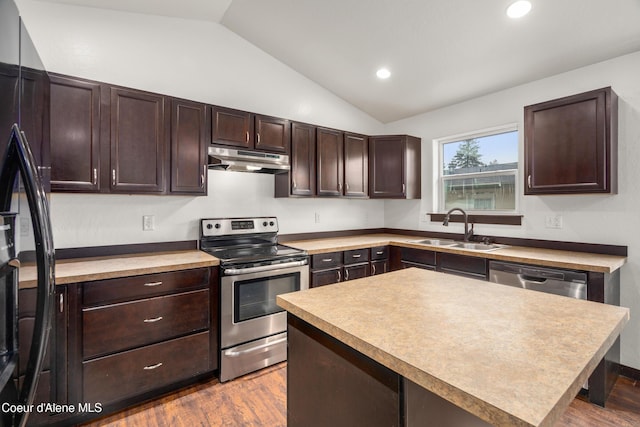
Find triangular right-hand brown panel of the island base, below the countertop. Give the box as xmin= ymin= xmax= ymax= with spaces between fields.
xmin=403 ymin=378 xmax=491 ymax=427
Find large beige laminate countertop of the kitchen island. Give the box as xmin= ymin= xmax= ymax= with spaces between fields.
xmin=278 ymin=268 xmax=629 ymax=426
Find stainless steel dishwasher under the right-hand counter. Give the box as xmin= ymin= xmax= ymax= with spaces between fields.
xmin=489 ymin=261 xmax=587 ymax=299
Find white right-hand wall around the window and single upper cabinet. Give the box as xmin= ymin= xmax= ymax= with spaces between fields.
xmin=385 ymin=52 xmax=640 ymax=369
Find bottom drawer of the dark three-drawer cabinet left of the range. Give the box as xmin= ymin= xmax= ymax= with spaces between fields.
xmin=82 ymin=332 xmax=209 ymax=405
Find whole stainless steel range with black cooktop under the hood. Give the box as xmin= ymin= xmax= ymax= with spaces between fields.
xmin=200 ymin=217 xmax=309 ymax=381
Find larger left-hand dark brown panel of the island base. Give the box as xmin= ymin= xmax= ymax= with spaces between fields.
xmin=287 ymin=314 xmax=404 ymax=427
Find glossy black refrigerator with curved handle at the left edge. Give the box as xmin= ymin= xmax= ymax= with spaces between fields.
xmin=0 ymin=0 xmax=55 ymax=427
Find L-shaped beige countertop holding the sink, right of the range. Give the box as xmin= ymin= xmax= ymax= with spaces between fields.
xmin=286 ymin=234 xmax=626 ymax=273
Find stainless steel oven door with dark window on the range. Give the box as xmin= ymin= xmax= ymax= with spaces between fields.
xmin=220 ymin=262 xmax=309 ymax=349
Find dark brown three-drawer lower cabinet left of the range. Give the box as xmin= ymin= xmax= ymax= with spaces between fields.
xmin=68 ymin=267 xmax=219 ymax=422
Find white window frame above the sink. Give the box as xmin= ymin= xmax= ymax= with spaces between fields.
xmin=432 ymin=123 xmax=522 ymax=217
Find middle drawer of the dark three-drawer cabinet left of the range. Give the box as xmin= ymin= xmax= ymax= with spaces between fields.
xmin=82 ymin=289 xmax=209 ymax=359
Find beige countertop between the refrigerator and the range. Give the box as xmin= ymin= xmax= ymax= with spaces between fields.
xmin=19 ymin=250 xmax=220 ymax=289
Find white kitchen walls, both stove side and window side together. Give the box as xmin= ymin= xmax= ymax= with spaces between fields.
xmin=11 ymin=0 xmax=640 ymax=369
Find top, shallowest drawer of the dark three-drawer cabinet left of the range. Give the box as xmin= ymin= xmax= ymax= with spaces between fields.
xmin=82 ymin=268 xmax=209 ymax=306
